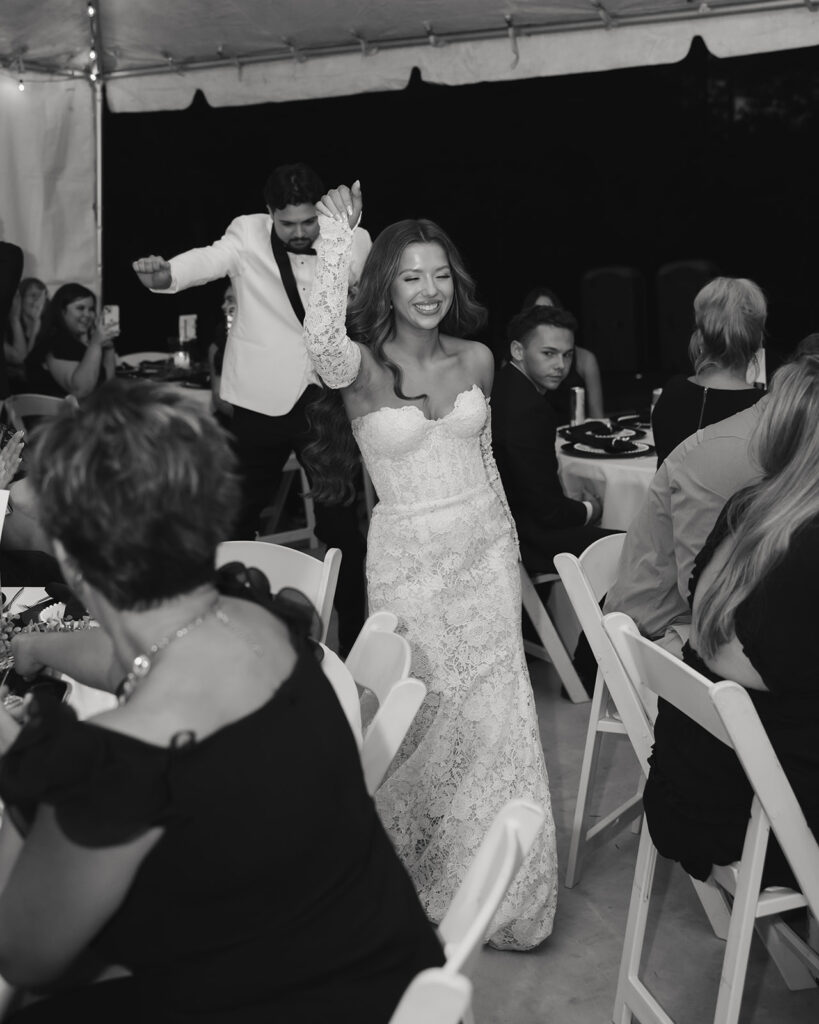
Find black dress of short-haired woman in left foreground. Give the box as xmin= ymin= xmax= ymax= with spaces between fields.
xmin=0 ymin=573 xmax=443 ymax=1024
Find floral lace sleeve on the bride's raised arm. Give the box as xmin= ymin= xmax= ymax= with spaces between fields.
xmin=304 ymin=216 xmax=361 ymax=388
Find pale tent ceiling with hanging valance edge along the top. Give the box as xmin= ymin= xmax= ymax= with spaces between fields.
xmin=0 ymin=0 xmax=819 ymax=110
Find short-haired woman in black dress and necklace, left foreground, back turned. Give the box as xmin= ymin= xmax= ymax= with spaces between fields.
xmin=0 ymin=381 xmax=443 ymax=1024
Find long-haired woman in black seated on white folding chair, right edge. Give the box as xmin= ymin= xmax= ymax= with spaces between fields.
xmin=643 ymin=355 xmax=819 ymax=886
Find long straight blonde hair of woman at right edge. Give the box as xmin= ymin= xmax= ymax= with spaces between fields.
xmin=694 ymin=355 xmax=819 ymax=659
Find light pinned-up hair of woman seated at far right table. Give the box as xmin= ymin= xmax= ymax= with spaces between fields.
xmin=688 ymin=278 xmax=768 ymax=373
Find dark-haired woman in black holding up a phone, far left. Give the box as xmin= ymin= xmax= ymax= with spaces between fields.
xmin=26 ymin=285 xmax=120 ymax=398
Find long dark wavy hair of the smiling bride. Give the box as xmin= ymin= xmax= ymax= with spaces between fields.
xmin=303 ymin=220 xmax=486 ymax=505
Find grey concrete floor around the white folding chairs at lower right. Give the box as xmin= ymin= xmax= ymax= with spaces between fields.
xmin=470 ymin=660 xmax=819 ymax=1024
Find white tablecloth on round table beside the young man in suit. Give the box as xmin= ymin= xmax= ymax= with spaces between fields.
xmin=557 ymin=438 xmax=657 ymax=529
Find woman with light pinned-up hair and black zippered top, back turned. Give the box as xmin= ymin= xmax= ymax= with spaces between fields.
xmin=651 ymin=278 xmax=768 ymax=466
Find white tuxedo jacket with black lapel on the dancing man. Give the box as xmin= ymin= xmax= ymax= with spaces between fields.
xmin=157 ymin=213 xmax=372 ymax=416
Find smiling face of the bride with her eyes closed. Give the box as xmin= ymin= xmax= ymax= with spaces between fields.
xmin=390 ymin=242 xmax=455 ymax=330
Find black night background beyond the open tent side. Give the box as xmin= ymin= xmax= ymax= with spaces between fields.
xmin=103 ymin=40 xmax=819 ymax=385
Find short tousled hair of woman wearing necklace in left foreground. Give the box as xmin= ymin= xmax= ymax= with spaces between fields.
xmin=31 ymin=380 xmax=240 ymax=609
